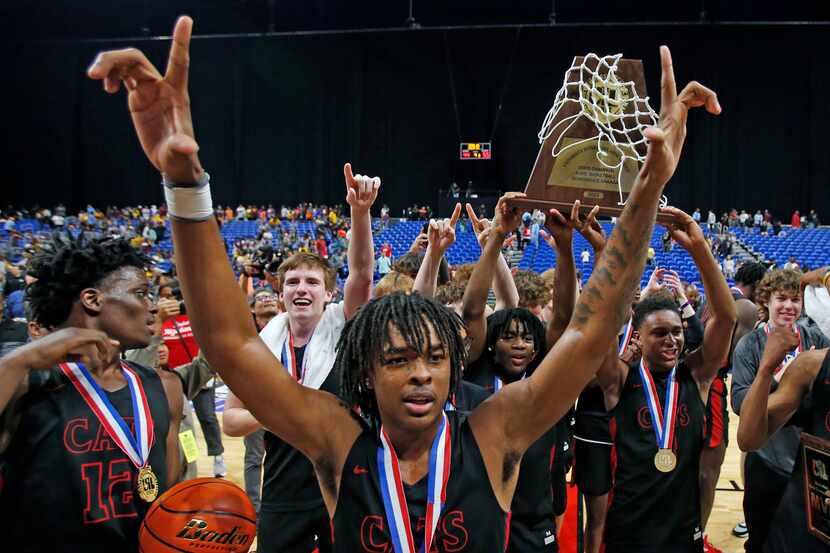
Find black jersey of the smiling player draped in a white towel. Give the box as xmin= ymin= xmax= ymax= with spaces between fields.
xmin=260 ymin=346 xmax=340 ymax=512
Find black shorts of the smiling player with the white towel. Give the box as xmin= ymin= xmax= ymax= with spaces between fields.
xmin=257 ymin=504 xmax=332 ymax=553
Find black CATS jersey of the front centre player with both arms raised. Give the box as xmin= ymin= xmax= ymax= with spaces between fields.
xmin=333 ymin=411 xmax=507 ymax=553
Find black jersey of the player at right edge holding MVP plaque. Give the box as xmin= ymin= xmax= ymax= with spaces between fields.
xmin=764 ymin=355 xmax=830 ymax=553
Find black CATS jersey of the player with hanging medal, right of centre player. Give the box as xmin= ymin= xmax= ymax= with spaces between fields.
xmin=605 ymin=363 xmax=705 ymax=553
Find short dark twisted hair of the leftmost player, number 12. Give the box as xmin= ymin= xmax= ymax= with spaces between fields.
xmin=26 ymin=234 xmax=148 ymax=328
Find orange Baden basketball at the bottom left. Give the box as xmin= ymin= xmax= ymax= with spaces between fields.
xmin=138 ymin=478 xmax=256 ymax=553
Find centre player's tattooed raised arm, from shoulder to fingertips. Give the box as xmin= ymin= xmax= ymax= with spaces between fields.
xmin=470 ymin=47 xmax=720 ymax=495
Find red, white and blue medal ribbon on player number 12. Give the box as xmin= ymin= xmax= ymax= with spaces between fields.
xmin=59 ymin=363 xmax=155 ymax=469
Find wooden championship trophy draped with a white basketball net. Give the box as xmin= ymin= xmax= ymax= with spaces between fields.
xmin=510 ymin=54 xmax=674 ymax=222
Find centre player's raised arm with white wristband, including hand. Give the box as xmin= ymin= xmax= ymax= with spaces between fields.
xmin=88 ymin=17 xmax=359 ymax=474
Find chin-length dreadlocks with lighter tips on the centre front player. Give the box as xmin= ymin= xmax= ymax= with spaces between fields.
xmin=334 ymin=292 xmax=466 ymax=430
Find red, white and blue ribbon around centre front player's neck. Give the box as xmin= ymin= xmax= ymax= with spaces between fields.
xmin=377 ymin=412 xmax=452 ymax=553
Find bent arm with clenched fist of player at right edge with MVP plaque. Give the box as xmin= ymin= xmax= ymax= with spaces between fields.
xmin=737 ymin=338 xmax=828 ymax=451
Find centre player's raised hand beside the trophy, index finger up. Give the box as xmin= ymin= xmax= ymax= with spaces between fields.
xmin=640 ymin=46 xmax=721 ymax=186
